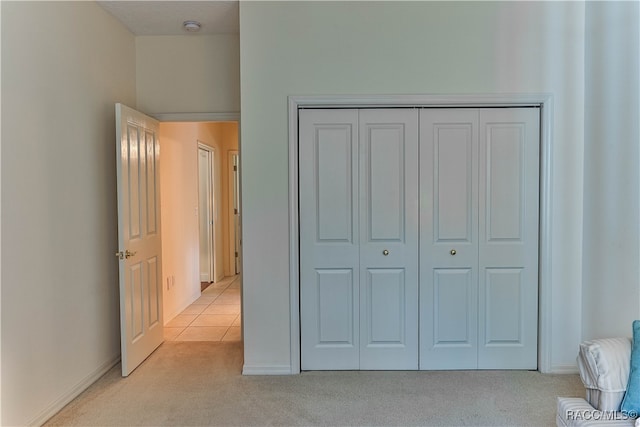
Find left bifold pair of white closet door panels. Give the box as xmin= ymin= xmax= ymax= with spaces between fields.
xmin=299 ymin=109 xmax=418 ymax=370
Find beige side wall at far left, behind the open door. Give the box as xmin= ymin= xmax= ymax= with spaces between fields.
xmin=1 ymin=2 xmax=135 ymax=425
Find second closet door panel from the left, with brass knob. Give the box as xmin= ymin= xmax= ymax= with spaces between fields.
xmin=360 ymin=109 xmax=418 ymax=369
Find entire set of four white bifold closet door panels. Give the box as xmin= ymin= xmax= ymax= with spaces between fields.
xmin=299 ymin=108 xmax=540 ymax=370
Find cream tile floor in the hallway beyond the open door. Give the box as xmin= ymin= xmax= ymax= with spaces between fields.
xmin=164 ymin=276 xmax=241 ymax=341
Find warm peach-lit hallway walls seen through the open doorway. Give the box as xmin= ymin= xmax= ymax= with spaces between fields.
xmin=158 ymin=120 xmax=240 ymax=332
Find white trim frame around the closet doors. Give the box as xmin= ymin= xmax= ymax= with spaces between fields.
xmin=288 ymin=93 xmax=553 ymax=374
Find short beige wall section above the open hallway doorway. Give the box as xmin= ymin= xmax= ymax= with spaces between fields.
xmin=136 ymin=34 xmax=240 ymax=114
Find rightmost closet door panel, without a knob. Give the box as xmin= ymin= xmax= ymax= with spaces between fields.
xmin=478 ymin=108 xmax=540 ymax=369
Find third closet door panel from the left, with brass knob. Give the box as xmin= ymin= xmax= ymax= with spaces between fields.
xmin=420 ymin=109 xmax=478 ymax=369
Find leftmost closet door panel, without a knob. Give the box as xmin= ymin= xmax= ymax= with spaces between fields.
xmin=299 ymin=110 xmax=360 ymax=370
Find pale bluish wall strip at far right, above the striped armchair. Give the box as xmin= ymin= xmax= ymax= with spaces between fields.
xmin=582 ymin=2 xmax=640 ymax=339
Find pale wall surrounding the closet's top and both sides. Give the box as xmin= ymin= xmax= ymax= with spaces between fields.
xmin=240 ymin=2 xmax=584 ymax=371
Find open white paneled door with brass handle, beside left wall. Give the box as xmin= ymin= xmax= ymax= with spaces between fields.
xmin=116 ymin=104 xmax=164 ymax=377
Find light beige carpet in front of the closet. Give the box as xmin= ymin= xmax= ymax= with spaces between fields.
xmin=46 ymin=342 xmax=584 ymax=426
